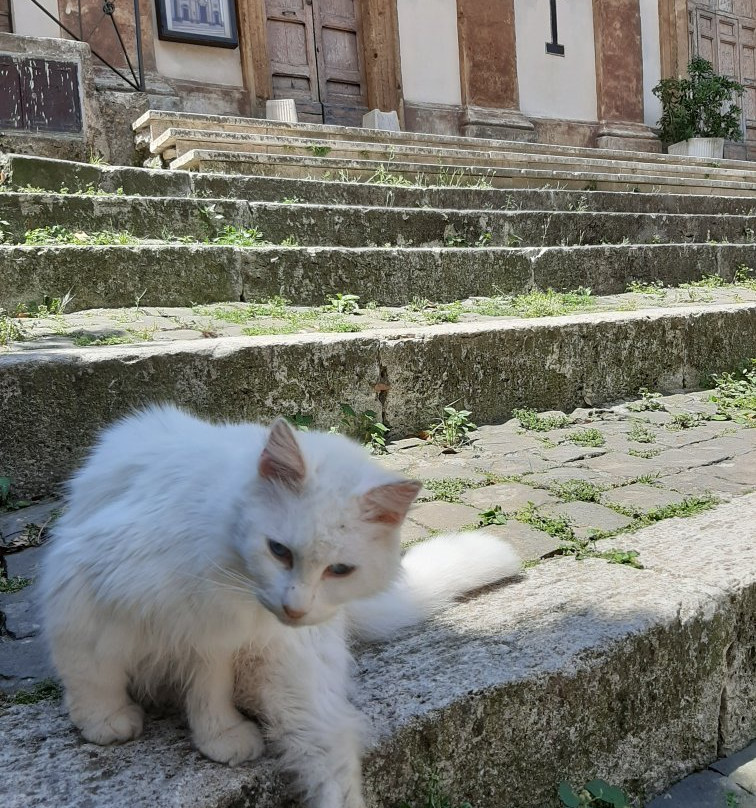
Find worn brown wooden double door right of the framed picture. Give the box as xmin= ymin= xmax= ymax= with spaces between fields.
xmin=265 ymin=0 xmax=367 ymax=126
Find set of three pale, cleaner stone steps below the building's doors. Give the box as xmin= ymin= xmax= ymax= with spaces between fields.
xmin=134 ymin=111 xmax=756 ymax=196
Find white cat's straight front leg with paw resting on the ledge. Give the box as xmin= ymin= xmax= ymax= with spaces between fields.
xmin=186 ymin=650 xmax=264 ymax=766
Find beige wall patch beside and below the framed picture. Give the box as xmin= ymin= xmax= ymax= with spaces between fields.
xmin=149 ymin=0 xmax=244 ymax=87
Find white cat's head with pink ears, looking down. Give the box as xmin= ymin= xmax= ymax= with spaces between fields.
xmin=237 ymin=419 xmax=421 ymax=626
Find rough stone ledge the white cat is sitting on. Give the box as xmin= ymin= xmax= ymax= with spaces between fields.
xmin=0 ymin=495 xmax=756 ymax=808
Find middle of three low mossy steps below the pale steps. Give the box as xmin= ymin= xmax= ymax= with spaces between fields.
xmin=0 ymin=192 xmax=756 ymax=247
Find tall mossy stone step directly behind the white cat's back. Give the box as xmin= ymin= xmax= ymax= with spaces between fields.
xmin=0 ymin=303 xmax=756 ymax=498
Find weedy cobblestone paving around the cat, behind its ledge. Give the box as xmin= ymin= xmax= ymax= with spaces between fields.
xmin=0 ymin=391 xmax=756 ymax=808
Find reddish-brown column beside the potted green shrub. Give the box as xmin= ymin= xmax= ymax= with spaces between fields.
xmin=593 ymin=0 xmax=661 ymax=152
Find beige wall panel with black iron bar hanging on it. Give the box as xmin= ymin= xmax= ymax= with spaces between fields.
xmin=515 ymin=0 xmax=596 ymax=121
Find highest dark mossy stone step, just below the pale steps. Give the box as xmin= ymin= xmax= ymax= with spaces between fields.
xmin=5 ymin=155 xmax=756 ymax=216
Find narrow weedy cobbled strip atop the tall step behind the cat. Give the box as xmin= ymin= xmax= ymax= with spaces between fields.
xmin=5 ymin=280 xmax=756 ymax=351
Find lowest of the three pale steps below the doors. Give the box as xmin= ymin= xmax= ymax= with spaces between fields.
xmin=171 ymin=149 xmax=756 ymax=197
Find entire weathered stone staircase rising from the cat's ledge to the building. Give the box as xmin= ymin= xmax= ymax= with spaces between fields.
xmin=0 ymin=134 xmax=756 ymax=808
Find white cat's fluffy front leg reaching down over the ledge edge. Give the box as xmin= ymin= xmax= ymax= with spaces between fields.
xmin=248 ymin=626 xmax=366 ymax=808
